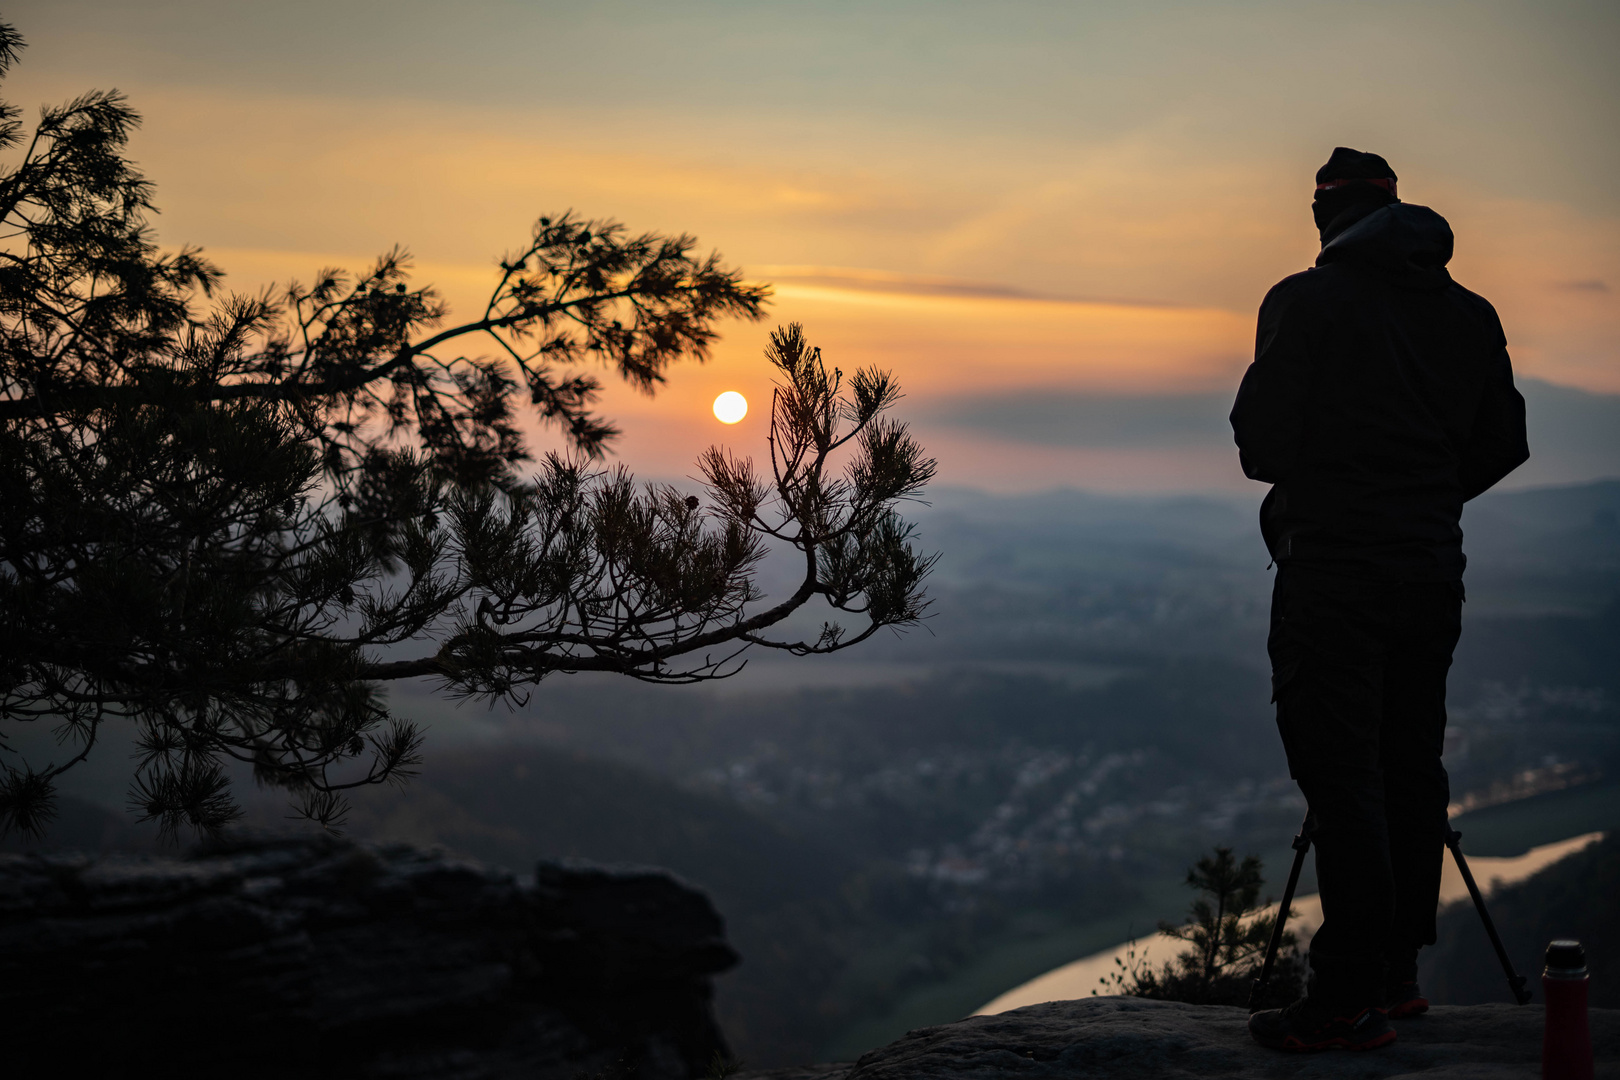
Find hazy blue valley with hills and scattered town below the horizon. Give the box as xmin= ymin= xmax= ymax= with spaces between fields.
xmin=9 ymin=481 xmax=1620 ymax=1065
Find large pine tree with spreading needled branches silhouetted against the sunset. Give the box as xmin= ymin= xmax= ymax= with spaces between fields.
xmin=0 ymin=26 xmax=933 ymax=834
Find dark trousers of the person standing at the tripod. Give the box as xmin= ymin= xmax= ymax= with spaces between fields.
xmin=1268 ymin=563 xmax=1463 ymax=1007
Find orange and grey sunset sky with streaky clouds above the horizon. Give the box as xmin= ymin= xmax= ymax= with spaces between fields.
xmin=5 ymin=0 xmax=1620 ymax=491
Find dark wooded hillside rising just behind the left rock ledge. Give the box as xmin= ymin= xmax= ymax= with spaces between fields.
xmin=332 ymin=745 xmax=887 ymax=1065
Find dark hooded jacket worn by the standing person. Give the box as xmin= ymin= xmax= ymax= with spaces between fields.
xmin=1231 ymin=202 xmax=1529 ymax=581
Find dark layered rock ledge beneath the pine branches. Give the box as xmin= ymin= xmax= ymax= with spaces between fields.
xmin=0 ymin=839 xmax=735 ymax=1080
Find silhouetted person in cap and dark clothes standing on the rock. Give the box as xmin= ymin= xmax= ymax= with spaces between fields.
xmin=1231 ymin=147 xmax=1529 ymax=1049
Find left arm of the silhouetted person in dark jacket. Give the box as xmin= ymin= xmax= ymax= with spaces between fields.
xmin=1231 ymin=282 xmax=1311 ymax=484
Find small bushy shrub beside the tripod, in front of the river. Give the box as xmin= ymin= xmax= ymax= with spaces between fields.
xmin=1092 ymin=847 xmax=1306 ymax=1009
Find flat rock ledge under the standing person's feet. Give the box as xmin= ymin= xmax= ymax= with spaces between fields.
xmin=842 ymin=997 xmax=1620 ymax=1080
